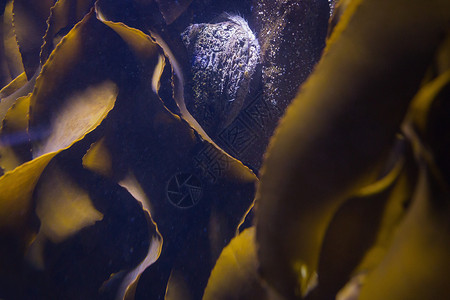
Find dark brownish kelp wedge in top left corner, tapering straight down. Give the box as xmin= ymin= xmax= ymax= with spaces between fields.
xmin=12 ymin=0 xmax=56 ymax=79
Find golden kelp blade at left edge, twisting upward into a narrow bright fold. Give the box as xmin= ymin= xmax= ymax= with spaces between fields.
xmin=0 ymin=88 xmax=115 ymax=298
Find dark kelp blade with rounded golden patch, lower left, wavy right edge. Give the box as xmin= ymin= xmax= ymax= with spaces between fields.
xmin=21 ymin=157 xmax=150 ymax=299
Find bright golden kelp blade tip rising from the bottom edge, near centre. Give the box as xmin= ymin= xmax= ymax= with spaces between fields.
xmin=203 ymin=227 xmax=273 ymax=300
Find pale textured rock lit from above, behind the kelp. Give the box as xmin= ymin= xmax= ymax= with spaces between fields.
xmin=182 ymin=14 xmax=260 ymax=135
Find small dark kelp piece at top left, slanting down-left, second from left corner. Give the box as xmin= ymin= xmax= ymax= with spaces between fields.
xmin=40 ymin=0 xmax=95 ymax=64
